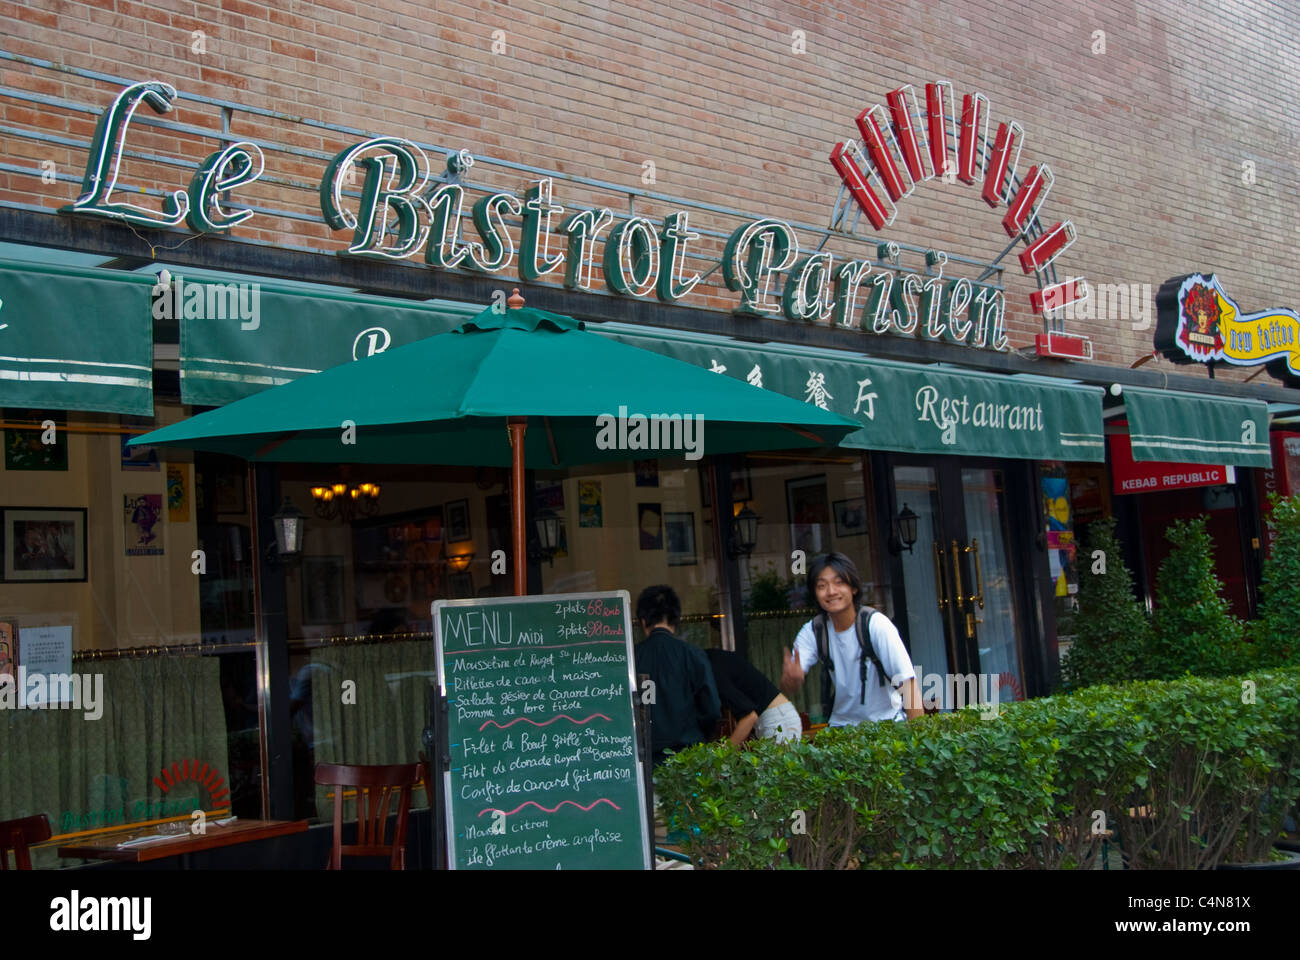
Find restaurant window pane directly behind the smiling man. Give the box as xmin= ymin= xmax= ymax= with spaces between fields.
xmin=732 ymin=450 xmax=892 ymax=723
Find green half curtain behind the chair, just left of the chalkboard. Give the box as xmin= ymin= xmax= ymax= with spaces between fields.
xmin=312 ymin=640 xmax=437 ymax=820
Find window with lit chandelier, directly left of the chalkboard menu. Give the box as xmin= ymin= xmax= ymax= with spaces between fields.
xmin=276 ymin=464 xmax=514 ymax=820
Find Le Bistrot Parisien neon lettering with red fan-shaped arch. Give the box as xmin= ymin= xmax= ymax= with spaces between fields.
xmin=62 ymin=81 xmax=1091 ymax=358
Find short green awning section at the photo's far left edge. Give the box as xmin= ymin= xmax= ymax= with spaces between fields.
xmin=0 ymin=260 xmax=155 ymax=416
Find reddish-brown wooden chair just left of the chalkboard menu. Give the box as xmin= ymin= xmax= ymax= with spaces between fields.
xmin=316 ymin=764 xmax=420 ymax=870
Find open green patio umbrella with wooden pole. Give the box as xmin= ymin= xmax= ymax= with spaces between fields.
xmin=131 ymin=290 xmax=861 ymax=593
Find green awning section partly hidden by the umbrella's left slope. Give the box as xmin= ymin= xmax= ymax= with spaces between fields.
xmin=172 ymin=271 xmax=482 ymax=406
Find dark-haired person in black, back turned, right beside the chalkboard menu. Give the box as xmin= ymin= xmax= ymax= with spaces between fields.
xmin=633 ymin=584 xmax=722 ymax=766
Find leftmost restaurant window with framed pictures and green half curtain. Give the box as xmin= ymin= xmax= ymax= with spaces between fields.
xmin=0 ymin=401 xmax=261 ymax=868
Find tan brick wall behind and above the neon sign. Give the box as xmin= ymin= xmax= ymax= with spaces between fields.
xmin=0 ymin=0 xmax=1300 ymax=366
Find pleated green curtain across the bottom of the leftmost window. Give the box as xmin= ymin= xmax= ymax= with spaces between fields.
xmin=0 ymin=656 xmax=230 ymax=868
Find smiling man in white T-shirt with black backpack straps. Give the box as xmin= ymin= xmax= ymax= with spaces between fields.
xmin=781 ymin=553 xmax=924 ymax=727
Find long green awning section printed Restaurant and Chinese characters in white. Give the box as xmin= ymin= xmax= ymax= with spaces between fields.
xmin=590 ymin=323 xmax=1105 ymax=462
